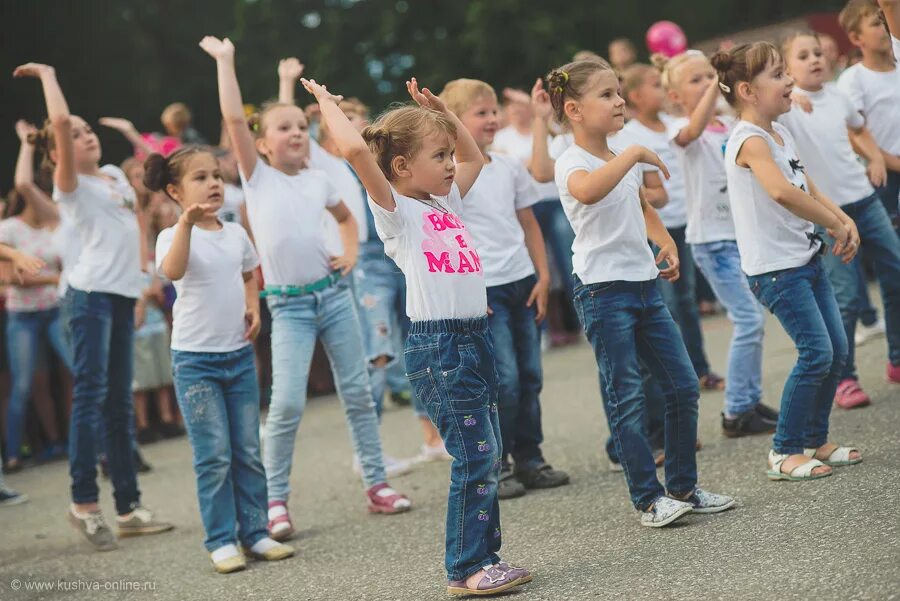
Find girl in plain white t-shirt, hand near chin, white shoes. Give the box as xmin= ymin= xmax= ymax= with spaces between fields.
xmin=144 ymin=146 xmax=294 ymax=574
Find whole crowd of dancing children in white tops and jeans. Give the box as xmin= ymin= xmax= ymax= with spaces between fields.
xmin=0 ymin=0 xmax=900 ymax=595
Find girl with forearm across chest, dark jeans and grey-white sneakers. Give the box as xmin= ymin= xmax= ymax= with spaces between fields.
xmin=547 ymin=61 xmax=734 ymax=527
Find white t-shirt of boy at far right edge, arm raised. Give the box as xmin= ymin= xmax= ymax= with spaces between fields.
xmin=837 ymin=36 xmax=900 ymax=154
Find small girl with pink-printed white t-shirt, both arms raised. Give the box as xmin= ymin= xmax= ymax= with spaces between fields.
xmin=301 ymin=79 xmax=531 ymax=595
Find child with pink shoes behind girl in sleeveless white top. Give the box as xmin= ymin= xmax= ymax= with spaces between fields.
xmin=779 ymin=30 xmax=900 ymax=400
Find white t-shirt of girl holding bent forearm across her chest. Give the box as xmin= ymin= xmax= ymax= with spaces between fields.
xmin=556 ymin=144 xmax=659 ymax=284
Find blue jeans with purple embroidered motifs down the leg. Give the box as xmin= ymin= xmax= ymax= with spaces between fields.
xmin=405 ymin=317 xmax=501 ymax=580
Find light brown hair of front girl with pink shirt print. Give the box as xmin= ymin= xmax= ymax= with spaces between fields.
xmin=362 ymin=105 xmax=456 ymax=181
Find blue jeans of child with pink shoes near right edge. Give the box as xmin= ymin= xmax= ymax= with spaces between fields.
xmin=823 ymin=194 xmax=900 ymax=380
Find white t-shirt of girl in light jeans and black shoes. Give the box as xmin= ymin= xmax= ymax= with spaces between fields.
xmin=669 ymin=116 xmax=734 ymax=244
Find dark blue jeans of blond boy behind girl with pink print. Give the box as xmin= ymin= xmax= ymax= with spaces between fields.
xmin=487 ymin=275 xmax=544 ymax=469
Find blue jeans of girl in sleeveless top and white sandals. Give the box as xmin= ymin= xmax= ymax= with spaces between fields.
xmin=748 ymin=255 xmax=847 ymax=455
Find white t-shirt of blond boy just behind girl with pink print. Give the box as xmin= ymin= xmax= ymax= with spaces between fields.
xmin=462 ymin=152 xmax=541 ymax=287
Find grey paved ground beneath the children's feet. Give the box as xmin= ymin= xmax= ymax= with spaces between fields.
xmin=0 ymin=300 xmax=900 ymax=601
